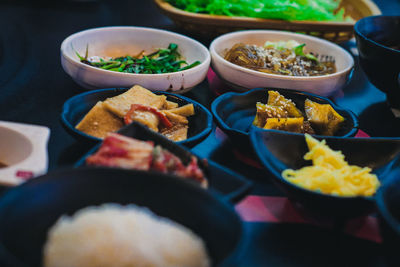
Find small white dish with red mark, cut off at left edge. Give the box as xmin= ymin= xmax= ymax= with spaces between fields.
xmin=0 ymin=121 xmax=50 ymax=186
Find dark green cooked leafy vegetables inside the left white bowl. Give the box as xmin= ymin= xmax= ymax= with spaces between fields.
xmin=76 ymin=43 xmax=200 ymax=74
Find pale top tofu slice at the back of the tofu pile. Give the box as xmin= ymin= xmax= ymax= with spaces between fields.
xmin=104 ymin=85 xmax=167 ymax=118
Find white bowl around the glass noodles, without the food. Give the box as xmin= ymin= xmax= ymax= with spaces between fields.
xmin=210 ymin=30 xmax=354 ymax=96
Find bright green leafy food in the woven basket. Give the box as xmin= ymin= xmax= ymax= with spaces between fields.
xmin=166 ymin=0 xmax=351 ymax=21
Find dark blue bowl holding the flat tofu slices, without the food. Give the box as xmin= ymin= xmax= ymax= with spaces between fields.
xmin=61 ymin=88 xmax=212 ymax=147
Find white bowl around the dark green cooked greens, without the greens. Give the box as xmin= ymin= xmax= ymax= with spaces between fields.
xmin=61 ymin=27 xmax=210 ymax=92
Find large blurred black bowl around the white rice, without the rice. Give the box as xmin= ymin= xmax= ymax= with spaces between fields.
xmin=0 ymin=168 xmax=242 ymax=267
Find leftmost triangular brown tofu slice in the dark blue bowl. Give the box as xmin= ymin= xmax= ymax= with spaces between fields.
xmin=75 ymin=101 xmax=124 ymax=138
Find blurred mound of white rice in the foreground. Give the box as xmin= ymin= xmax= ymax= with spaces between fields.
xmin=43 ymin=204 xmax=210 ymax=267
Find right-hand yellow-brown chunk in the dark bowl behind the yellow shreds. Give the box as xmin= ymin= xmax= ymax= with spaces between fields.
xmin=304 ymin=99 xmax=344 ymax=135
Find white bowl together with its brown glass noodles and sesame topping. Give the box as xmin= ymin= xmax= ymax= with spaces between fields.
xmin=210 ymin=30 xmax=354 ymax=96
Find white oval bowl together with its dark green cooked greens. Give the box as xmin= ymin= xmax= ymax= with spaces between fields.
xmin=61 ymin=27 xmax=210 ymax=92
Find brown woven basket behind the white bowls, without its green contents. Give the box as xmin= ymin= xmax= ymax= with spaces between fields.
xmin=154 ymin=0 xmax=381 ymax=43
